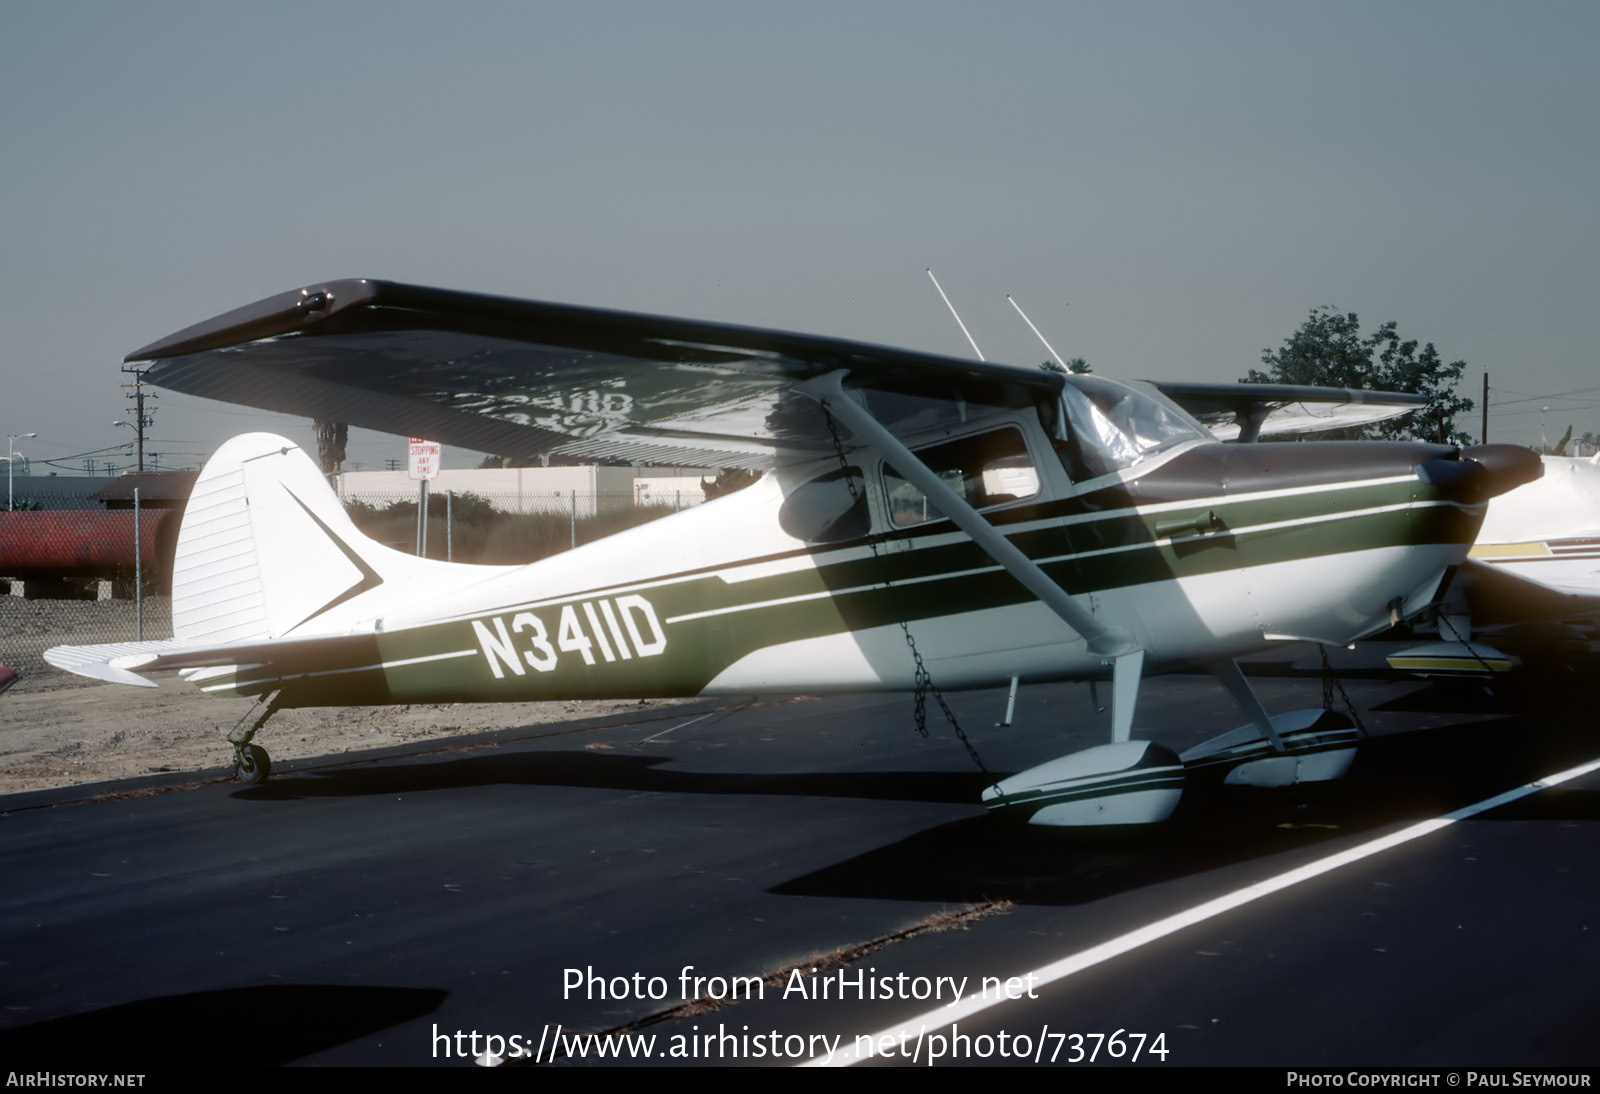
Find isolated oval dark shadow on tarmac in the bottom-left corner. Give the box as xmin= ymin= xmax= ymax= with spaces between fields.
xmin=0 ymin=984 xmax=450 ymax=1073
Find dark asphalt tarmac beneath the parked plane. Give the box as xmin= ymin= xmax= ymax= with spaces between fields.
xmin=0 ymin=649 xmax=1600 ymax=1072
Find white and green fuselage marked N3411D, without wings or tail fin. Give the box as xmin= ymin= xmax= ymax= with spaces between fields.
xmin=198 ymin=411 xmax=1504 ymax=705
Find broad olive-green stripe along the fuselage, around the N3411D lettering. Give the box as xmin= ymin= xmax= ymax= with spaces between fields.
xmin=225 ymin=478 xmax=1482 ymax=705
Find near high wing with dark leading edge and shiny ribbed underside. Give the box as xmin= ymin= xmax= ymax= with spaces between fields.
xmin=128 ymin=280 xmax=1062 ymax=470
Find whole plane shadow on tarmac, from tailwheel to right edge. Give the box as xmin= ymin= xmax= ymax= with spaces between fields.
xmin=234 ymin=686 xmax=1600 ymax=905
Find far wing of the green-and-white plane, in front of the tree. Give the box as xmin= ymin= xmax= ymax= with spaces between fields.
xmin=1155 ymin=381 xmax=1427 ymax=441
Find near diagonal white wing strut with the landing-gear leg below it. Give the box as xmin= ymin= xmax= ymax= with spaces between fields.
xmin=800 ymin=369 xmax=1144 ymax=722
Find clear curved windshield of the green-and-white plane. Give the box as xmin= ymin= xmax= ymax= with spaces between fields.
xmin=1056 ymin=376 xmax=1210 ymax=481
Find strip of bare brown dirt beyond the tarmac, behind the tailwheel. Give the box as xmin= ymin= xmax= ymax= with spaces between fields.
xmin=0 ymin=673 xmax=688 ymax=795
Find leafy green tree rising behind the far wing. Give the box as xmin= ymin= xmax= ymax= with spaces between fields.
xmin=1242 ymin=307 xmax=1472 ymax=445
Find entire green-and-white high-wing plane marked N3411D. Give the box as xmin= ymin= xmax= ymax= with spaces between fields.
xmin=46 ymin=280 xmax=1539 ymax=824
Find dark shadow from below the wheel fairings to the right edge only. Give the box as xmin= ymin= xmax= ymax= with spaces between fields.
xmin=771 ymin=720 xmax=1600 ymax=905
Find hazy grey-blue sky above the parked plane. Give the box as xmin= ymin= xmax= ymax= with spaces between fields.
xmin=0 ymin=0 xmax=1600 ymax=473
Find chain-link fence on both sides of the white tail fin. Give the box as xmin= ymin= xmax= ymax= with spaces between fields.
xmin=0 ymin=489 xmax=704 ymax=690
